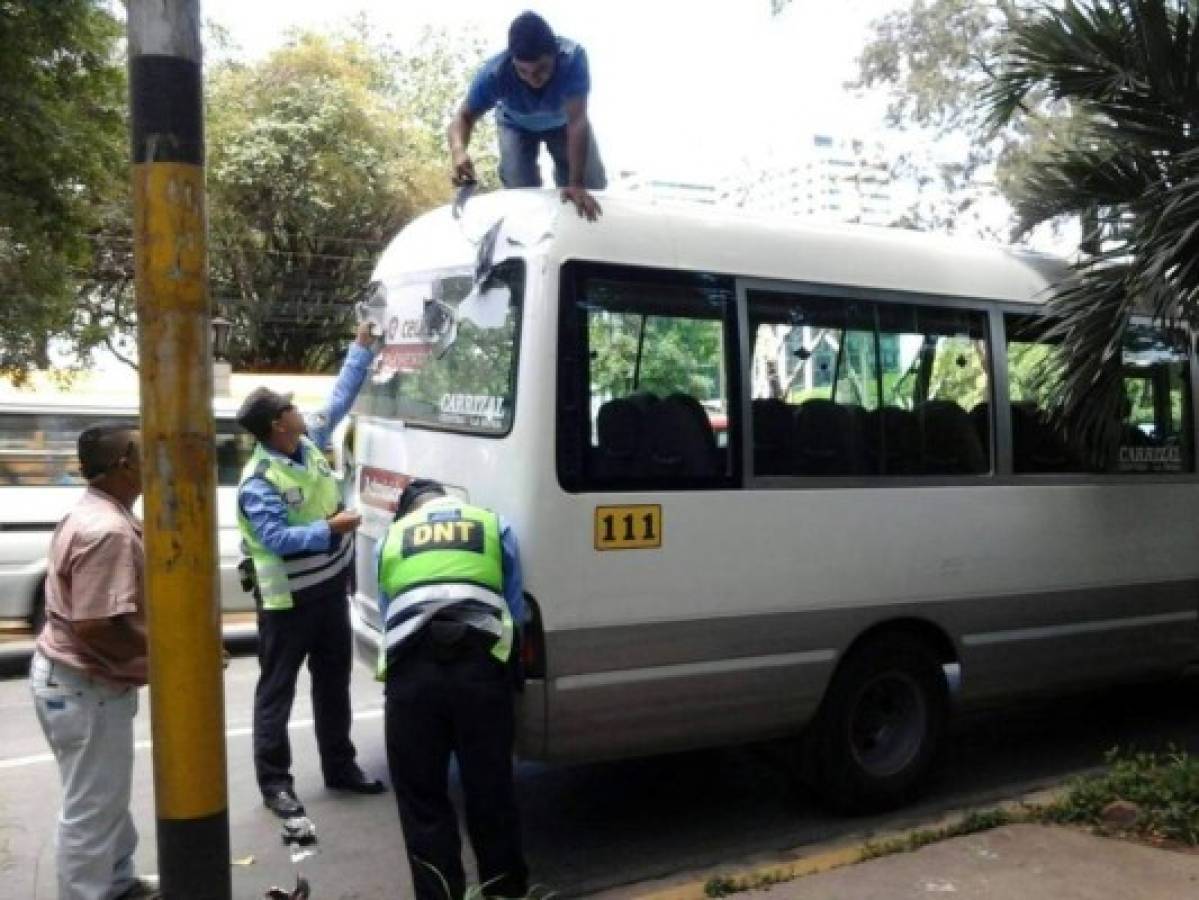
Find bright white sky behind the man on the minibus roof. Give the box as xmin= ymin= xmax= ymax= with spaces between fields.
xmin=201 ymin=0 xmax=906 ymax=179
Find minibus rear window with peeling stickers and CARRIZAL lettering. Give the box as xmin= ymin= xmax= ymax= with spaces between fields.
xmin=357 ymin=259 xmax=524 ymax=435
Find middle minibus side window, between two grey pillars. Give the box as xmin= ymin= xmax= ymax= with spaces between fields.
xmin=747 ymin=290 xmax=992 ymax=477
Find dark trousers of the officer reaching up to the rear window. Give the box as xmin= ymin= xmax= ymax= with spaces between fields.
xmin=254 ymin=578 xmax=355 ymax=795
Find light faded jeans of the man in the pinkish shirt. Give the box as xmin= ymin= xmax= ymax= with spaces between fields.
xmin=30 ymin=653 xmax=138 ymax=900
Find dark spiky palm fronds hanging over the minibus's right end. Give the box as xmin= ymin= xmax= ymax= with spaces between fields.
xmin=988 ymin=0 xmax=1199 ymax=449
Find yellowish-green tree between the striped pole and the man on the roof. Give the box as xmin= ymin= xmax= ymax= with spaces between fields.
xmin=207 ymin=25 xmax=489 ymax=370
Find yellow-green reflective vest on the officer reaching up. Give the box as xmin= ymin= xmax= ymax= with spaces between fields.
xmin=237 ymin=437 xmax=354 ymax=610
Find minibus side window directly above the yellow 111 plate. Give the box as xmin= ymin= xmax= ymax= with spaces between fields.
xmin=560 ymin=272 xmax=736 ymax=489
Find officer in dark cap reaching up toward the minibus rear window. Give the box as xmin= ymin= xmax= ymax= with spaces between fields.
xmin=237 ymin=324 xmax=385 ymax=819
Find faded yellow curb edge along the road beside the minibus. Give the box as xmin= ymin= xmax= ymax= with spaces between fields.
xmin=625 ymin=785 xmax=1065 ymax=900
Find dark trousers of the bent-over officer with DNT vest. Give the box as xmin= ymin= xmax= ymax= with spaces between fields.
xmin=385 ymin=635 xmax=528 ymax=900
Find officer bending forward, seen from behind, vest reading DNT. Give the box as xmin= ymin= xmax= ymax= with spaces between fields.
xmin=379 ymin=478 xmax=529 ymax=900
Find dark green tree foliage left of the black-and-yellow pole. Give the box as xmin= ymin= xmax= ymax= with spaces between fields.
xmin=0 ymin=0 xmax=128 ymax=380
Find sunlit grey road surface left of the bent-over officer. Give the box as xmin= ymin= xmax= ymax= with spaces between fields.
xmin=0 ymin=659 xmax=412 ymax=900
